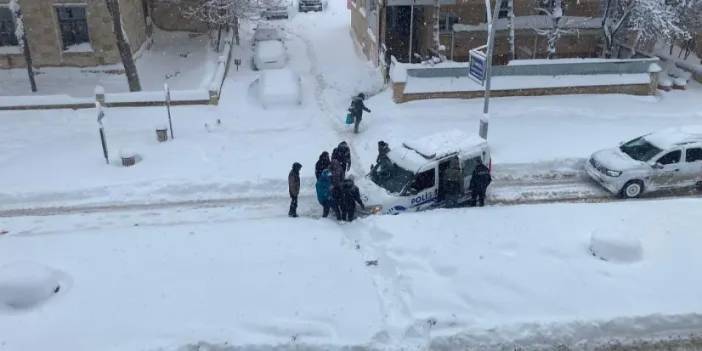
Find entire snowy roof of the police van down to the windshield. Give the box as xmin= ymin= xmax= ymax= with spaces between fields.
xmin=388 ymin=130 xmax=487 ymax=172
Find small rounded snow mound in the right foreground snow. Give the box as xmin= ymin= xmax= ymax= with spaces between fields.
xmin=590 ymin=230 xmax=643 ymax=263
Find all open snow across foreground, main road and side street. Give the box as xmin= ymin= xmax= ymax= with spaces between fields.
xmin=0 ymin=3 xmax=702 ymax=351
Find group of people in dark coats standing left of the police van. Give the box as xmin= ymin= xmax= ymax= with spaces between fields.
xmin=288 ymin=141 xmax=365 ymax=222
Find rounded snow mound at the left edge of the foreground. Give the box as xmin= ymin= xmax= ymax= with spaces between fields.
xmin=0 ymin=262 xmax=61 ymax=310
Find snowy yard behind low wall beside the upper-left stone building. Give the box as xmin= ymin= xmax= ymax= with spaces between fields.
xmin=0 ymin=29 xmax=218 ymax=97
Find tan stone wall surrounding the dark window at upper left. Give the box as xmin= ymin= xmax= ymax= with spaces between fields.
xmin=0 ymin=0 xmax=146 ymax=68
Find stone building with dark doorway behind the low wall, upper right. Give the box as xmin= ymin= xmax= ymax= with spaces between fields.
xmin=348 ymin=0 xmax=602 ymax=64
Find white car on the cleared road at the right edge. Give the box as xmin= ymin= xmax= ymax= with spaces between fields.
xmin=585 ymin=126 xmax=702 ymax=198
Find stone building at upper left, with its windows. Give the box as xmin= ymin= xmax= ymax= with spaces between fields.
xmin=0 ymin=0 xmax=203 ymax=68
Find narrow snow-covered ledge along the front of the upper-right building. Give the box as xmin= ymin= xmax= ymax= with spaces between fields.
xmin=453 ymin=15 xmax=602 ymax=32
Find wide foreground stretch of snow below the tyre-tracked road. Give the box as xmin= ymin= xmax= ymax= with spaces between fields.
xmin=0 ymin=199 xmax=702 ymax=351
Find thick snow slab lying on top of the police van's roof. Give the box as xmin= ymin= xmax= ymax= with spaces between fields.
xmin=403 ymin=130 xmax=487 ymax=160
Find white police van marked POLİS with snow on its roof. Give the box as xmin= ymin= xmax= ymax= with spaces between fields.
xmin=358 ymin=131 xmax=491 ymax=214
